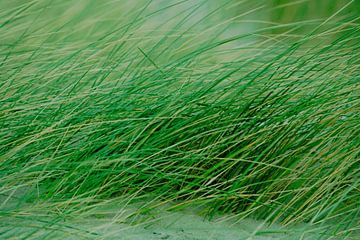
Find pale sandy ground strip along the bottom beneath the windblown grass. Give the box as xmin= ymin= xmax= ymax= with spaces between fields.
xmin=0 ymin=202 xmax=335 ymax=240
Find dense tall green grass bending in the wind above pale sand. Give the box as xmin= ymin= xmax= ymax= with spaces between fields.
xmin=0 ymin=0 xmax=360 ymax=238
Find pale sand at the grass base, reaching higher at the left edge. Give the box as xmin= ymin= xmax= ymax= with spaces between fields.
xmin=0 ymin=193 xmax=348 ymax=240
